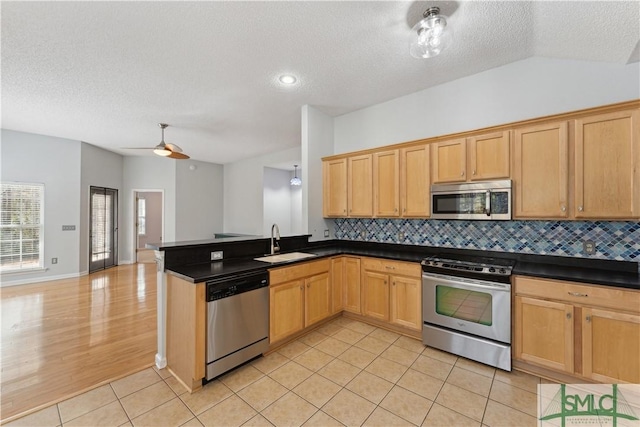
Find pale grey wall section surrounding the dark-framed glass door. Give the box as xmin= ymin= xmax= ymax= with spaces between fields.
xmin=79 ymin=142 xmax=124 ymax=274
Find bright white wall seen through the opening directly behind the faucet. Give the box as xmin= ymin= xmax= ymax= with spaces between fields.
xmin=262 ymin=167 xmax=292 ymax=236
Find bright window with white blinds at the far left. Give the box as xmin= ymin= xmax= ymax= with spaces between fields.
xmin=0 ymin=182 xmax=44 ymax=272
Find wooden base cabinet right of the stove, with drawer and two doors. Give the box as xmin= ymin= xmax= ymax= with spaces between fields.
xmin=513 ymin=276 xmax=640 ymax=383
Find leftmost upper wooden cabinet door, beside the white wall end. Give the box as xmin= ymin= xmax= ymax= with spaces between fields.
xmin=322 ymin=159 xmax=347 ymax=217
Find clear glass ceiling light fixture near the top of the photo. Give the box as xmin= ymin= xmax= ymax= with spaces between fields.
xmin=409 ymin=7 xmax=453 ymax=58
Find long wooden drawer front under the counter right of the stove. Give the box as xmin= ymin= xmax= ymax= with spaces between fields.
xmin=514 ymin=276 xmax=640 ymax=313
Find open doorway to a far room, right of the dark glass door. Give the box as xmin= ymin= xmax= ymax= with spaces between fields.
xmin=134 ymin=190 xmax=163 ymax=263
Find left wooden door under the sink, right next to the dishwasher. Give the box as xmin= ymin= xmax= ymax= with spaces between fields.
xmin=269 ymin=280 xmax=304 ymax=343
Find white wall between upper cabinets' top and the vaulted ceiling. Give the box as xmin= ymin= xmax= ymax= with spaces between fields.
xmin=334 ymin=58 xmax=640 ymax=154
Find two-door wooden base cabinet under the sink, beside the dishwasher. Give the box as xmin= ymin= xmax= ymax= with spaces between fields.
xmin=269 ymin=259 xmax=332 ymax=343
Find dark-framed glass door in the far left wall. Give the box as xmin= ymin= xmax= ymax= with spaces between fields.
xmin=89 ymin=187 xmax=118 ymax=273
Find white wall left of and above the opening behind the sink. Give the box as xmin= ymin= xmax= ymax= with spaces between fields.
xmin=223 ymin=147 xmax=304 ymax=236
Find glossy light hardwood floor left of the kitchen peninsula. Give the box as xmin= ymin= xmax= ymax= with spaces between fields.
xmin=0 ymin=264 xmax=157 ymax=422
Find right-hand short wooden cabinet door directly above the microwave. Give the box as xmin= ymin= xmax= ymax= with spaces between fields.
xmin=467 ymin=131 xmax=511 ymax=181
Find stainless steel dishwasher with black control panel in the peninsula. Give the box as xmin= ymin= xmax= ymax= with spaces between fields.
xmin=206 ymin=272 xmax=269 ymax=381
